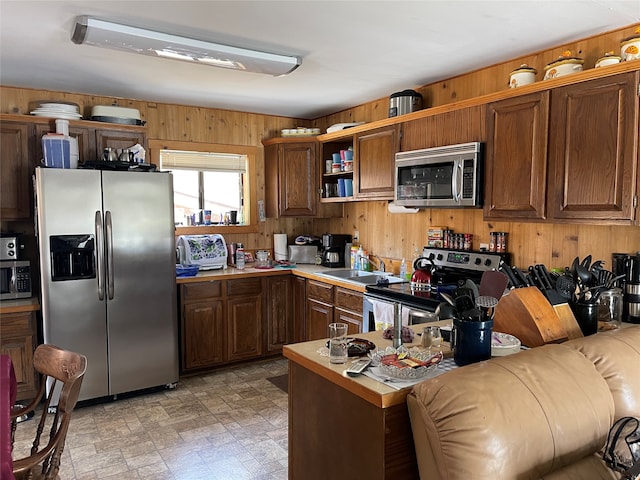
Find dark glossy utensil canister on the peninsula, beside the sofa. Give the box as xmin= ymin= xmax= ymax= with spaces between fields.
xmin=451 ymin=318 xmax=493 ymax=366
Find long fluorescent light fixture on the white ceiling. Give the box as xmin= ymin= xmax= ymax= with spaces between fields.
xmin=71 ymin=15 xmax=302 ymax=76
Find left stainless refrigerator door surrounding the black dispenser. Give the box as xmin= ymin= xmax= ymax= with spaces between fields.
xmin=35 ymin=168 xmax=109 ymax=400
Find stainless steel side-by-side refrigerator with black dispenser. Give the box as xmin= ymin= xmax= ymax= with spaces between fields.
xmin=35 ymin=168 xmax=178 ymax=400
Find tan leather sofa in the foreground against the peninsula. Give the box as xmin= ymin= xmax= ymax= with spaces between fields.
xmin=407 ymin=326 xmax=640 ymax=480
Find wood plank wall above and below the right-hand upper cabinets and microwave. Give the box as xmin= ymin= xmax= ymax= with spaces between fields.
xmin=314 ymin=25 xmax=640 ymax=271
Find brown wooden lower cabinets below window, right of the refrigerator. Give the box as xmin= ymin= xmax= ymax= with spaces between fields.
xmin=180 ymin=275 xmax=294 ymax=373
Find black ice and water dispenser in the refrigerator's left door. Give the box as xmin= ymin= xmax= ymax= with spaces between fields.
xmin=49 ymin=235 xmax=96 ymax=282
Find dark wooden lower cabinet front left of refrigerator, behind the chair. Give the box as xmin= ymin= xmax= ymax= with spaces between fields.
xmin=0 ymin=312 xmax=38 ymax=400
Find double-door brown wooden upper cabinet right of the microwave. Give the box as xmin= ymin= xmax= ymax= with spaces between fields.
xmin=484 ymin=72 xmax=638 ymax=224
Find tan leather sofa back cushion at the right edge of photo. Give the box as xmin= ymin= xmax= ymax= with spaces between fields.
xmin=563 ymin=326 xmax=640 ymax=419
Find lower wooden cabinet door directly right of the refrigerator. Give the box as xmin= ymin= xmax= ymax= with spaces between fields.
xmin=181 ymin=299 xmax=225 ymax=371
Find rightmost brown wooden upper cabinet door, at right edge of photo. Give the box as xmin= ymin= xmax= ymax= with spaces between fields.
xmin=548 ymin=72 xmax=638 ymax=224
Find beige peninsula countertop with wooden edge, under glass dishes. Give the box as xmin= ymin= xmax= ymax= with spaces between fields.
xmin=282 ymin=320 xmax=451 ymax=408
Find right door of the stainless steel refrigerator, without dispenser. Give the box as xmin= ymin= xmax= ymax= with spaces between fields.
xmin=102 ymin=171 xmax=178 ymax=395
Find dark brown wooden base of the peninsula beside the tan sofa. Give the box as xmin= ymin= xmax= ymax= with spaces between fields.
xmin=287 ymin=355 xmax=419 ymax=480
